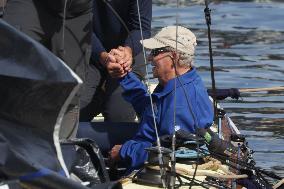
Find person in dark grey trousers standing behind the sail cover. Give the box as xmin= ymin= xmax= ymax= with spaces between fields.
xmin=3 ymin=0 xmax=93 ymax=138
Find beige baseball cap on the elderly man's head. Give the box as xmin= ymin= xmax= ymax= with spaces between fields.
xmin=140 ymin=26 xmax=197 ymax=56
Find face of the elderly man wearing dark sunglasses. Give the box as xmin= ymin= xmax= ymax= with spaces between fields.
xmin=149 ymin=48 xmax=173 ymax=79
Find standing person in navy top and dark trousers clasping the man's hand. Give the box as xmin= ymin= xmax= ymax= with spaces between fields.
xmin=80 ymin=0 xmax=152 ymax=122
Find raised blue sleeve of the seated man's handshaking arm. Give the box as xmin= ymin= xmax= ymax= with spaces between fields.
xmin=120 ymin=72 xmax=150 ymax=114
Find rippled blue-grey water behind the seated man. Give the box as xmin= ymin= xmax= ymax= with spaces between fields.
xmin=152 ymin=0 xmax=284 ymax=178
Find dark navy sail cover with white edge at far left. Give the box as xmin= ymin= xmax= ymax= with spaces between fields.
xmin=0 ymin=20 xmax=85 ymax=188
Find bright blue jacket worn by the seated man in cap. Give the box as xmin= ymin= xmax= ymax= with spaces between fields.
xmin=117 ymin=69 xmax=213 ymax=169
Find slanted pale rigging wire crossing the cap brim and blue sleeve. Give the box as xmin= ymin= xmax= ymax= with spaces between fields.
xmin=136 ymin=0 xmax=166 ymax=188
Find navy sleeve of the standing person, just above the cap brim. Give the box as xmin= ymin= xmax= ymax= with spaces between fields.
xmin=125 ymin=0 xmax=152 ymax=56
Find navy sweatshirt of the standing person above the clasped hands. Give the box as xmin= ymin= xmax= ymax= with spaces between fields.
xmin=92 ymin=0 xmax=152 ymax=61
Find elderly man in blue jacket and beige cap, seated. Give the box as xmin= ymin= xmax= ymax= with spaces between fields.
xmin=110 ymin=26 xmax=213 ymax=169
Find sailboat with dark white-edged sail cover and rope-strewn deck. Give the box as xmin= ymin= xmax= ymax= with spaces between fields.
xmin=0 ymin=0 xmax=282 ymax=189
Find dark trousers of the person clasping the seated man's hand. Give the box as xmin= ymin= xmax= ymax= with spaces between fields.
xmin=80 ymin=53 xmax=145 ymax=122
